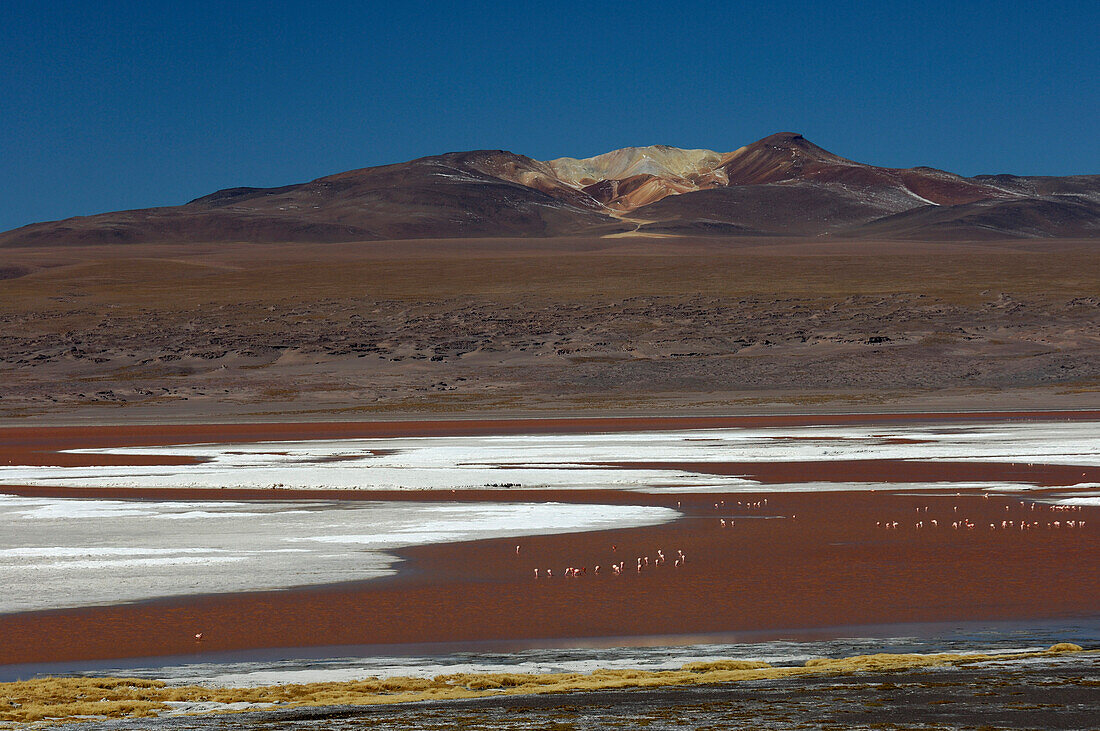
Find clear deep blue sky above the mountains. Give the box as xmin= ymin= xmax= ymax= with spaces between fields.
xmin=0 ymin=0 xmax=1100 ymax=230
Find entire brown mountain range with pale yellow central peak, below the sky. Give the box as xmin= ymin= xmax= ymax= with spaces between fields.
xmin=0 ymin=133 xmax=1100 ymax=246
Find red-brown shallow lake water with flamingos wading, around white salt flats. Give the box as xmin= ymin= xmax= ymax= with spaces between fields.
xmin=0 ymin=414 xmax=1100 ymax=664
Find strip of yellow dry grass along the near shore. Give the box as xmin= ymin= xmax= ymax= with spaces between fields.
xmin=0 ymin=642 xmax=1097 ymax=728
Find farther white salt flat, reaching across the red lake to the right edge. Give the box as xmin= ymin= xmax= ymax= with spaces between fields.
xmin=0 ymin=415 xmax=1100 ymax=491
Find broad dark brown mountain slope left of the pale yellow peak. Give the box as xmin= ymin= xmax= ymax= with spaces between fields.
xmin=0 ymin=151 xmax=626 ymax=246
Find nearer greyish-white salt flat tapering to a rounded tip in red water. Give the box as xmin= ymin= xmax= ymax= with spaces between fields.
xmin=0 ymin=496 xmax=678 ymax=612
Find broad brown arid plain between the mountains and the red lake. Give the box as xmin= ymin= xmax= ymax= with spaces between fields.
xmin=0 ymin=236 xmax=1100 ymax=425
